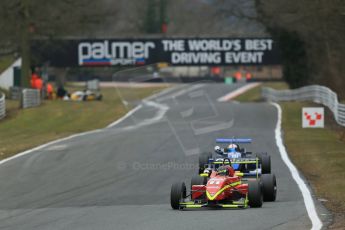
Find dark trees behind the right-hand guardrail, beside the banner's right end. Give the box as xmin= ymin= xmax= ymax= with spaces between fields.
xmin=256 ymin=0 xmax=345 ymax=98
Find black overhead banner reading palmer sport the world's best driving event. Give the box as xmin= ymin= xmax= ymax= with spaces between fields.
xmin=32 ymin=38 xmax=280 ymax=67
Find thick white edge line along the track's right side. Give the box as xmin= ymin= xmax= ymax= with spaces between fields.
xmin=270 ymin=102 xmax=322 ymax=230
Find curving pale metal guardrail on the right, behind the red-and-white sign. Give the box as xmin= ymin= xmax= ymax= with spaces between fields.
xmin=261 ymin=85 xmax=345 ymax=126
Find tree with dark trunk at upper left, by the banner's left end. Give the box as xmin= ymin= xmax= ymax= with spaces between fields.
xmin=0 ymin=0 xmax=105 ymax=86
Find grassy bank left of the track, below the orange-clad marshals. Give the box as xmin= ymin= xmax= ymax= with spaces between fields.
xmin=0 ymin=88 xmax=162 ymax=159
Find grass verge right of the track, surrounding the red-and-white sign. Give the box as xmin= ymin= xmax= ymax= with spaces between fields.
xmin=235 ymin=83 xmax=345 ymax=229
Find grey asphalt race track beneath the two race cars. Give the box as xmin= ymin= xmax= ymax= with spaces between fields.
xmin=0 ymin=83 xmax=326 ymax=230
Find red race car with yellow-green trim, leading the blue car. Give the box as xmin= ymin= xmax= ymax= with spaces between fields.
xmin=170 ymin=165 xmax=263 ymax=209
